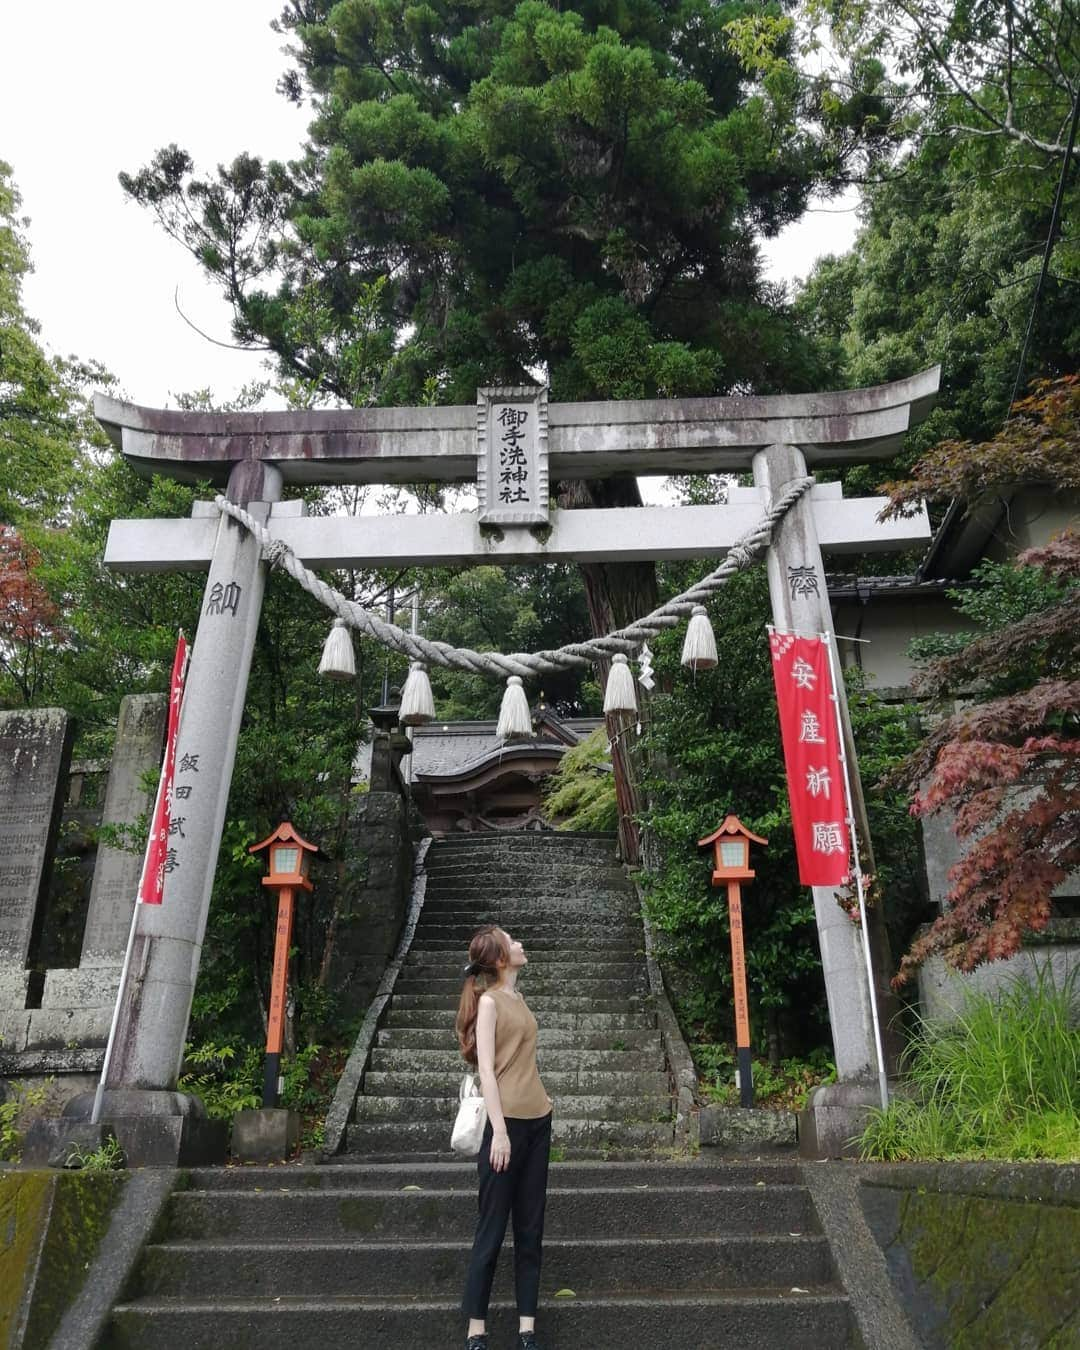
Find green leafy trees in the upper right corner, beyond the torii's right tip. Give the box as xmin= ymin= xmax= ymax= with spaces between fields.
xmin=797 ymin=0 xmax=1080 ymax=490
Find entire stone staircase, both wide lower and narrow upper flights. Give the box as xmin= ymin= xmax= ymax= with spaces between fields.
xmin=101 ymin=834 xmax=853 ymax=1350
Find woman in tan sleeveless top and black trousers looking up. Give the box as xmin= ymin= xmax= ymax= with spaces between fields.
xmin=456 ymin=925 xmax=551 ymax=1350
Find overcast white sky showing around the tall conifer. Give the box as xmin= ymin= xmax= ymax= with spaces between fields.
xmin=0 ymin=0 xmax=856 ymax=406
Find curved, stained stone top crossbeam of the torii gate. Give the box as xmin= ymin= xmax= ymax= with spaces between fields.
xmin=95 ymin=366 xmax=941 ymax=485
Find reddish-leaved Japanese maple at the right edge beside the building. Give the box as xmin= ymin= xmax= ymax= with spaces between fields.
xmin=888 ymin=375 xmax=1080 ymax=984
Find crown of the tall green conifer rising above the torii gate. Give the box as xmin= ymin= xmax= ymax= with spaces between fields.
xmin=122 ymin=0 xmax=880 ymax=404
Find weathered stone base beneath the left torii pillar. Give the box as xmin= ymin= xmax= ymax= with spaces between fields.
xmin=23 ymin=1088 xmax=228 ymax=1168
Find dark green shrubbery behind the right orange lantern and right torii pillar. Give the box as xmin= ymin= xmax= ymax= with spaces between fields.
xmin=644 ymin=568 xmax=918 ymax=1056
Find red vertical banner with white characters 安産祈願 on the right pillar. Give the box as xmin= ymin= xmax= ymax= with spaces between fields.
xmin=768 ymin=629 xmax=851 ymax=886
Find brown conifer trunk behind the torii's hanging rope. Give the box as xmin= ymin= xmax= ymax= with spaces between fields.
xmin=559 ymin=478 xmax=657 ymax=863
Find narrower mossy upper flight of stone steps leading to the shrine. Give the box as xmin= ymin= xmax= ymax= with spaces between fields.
xmin=346 ymin=833 xmax=674 ymax=1158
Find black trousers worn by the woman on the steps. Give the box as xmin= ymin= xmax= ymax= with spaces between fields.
xmin=462 ymin=1112 xmax=551 ymax=1319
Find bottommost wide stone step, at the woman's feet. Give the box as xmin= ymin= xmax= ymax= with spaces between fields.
xmin=108 ymin=1291 xmax=852 ymax=1350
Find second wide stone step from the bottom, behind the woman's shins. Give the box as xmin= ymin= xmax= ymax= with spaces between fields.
xmin=134 ymin=1234 xmax=833 ymax=1303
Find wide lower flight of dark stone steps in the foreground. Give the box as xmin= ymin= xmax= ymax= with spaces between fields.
xmin=101 ymin=1160 xmax=855 ymax=1350
